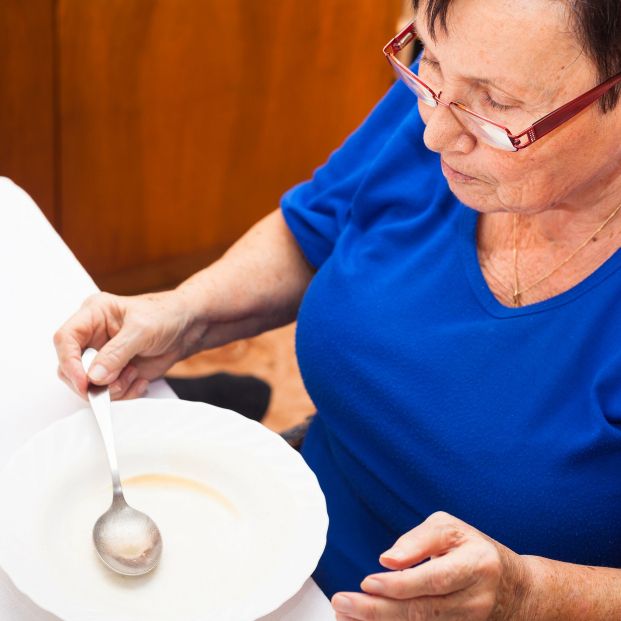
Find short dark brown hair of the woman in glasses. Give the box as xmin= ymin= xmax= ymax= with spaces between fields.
xmin=412 ymin=0 xmax=621 ymax=113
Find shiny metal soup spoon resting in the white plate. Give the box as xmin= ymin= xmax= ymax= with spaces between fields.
xmin=82 ymin=347 xmax=162 ymax=576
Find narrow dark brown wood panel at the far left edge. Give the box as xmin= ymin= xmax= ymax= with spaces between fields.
xmin=0 ymin=0 xmax=59 ymax=226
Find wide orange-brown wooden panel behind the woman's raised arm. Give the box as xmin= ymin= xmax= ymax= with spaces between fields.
xmin=57 ymin=0 xmax=401 ymax=291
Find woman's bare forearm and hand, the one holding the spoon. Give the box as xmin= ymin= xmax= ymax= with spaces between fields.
xmin=54 ymin=210 xmax=313 ymax=399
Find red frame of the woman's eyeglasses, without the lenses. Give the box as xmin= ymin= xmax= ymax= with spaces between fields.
xmin=384 ymin=22 xmax=621 ymax=151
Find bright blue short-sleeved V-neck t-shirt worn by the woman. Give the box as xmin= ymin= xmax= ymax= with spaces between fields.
xmin=282 ymin=76 xmax=621 ymax=596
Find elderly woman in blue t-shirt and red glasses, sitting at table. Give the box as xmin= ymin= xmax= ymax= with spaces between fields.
xmin=56 ymin=0 xmax=621 ymax=621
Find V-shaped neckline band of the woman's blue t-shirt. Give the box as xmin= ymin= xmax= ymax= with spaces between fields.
xmin=459 ymin=203 xmax=621 ymax=317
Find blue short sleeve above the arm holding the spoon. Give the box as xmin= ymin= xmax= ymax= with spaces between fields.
xmin=280 ymin=76 xmax=416 ymax=268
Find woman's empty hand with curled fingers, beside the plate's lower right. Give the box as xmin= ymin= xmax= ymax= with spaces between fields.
xmin=332 ymin=512 xmax=529 ymax=621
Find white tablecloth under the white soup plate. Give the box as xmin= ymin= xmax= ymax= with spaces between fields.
xmin=0 ymin=177 xmax=335 ymax=621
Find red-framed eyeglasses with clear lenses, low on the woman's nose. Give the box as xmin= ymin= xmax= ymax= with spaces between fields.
xmin=384 ymin=22 xmax=621 ymax=151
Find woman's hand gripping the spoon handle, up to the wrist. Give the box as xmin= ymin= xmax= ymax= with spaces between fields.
xmin=54 ymin=290 xmax=207 ymax=399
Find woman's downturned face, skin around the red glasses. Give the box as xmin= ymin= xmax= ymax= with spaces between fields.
xmin=416 ymin=0 xmax=621 ymax=213
